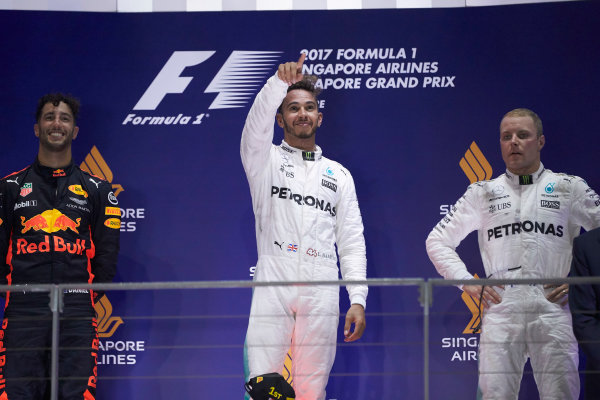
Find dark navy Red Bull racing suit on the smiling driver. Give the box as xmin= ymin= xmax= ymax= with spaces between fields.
xmin=0 ymin=160 xmax=120 ymax=400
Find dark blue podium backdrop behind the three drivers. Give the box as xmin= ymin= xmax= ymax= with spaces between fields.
xmin=0 ymin=2 xmax=600 ymax=400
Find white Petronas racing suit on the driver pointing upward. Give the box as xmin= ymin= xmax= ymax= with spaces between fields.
xmin=241 ymin=76 xmax=367 ymax=400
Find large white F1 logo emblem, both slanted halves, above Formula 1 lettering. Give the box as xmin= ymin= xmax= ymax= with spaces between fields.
xmin=133 ymin=50 xmax=281 ymax=110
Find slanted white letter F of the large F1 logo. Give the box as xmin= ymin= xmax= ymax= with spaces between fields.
xmin=133 ymin=51 xmax=215 ymax=110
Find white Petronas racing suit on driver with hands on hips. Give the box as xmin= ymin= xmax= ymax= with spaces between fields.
xmin=426 ymin=165 xmax=600 ymax=400
